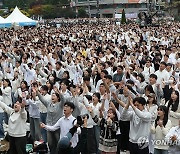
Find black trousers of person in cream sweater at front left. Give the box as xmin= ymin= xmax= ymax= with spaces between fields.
xmin=8 ymin=136 xmax=27 ymax=154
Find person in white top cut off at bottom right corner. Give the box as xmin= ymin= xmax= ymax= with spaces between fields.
xmin=165 ymin=119 xmax=180 ymax=154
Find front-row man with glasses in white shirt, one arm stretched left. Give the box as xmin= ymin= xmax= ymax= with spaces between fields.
xmin=41 ymin=102 xmax=78 ymax=154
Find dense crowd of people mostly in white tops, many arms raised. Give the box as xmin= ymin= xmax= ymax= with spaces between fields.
xmin=0 ymin=19 xmax=180 ymax=154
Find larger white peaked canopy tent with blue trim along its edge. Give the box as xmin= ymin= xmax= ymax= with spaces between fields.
xmin=5 ymin=6 xmax=37 ymax=26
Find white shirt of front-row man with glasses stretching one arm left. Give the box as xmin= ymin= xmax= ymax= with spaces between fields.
xmin=45 ymin=115 xmax=78 ymax=148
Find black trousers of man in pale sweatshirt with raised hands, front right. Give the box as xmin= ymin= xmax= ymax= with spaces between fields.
xmin=129 ymin=142 xmax=149 ymax=154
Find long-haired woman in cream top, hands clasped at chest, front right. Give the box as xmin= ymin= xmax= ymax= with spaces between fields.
xmin=151 ymin=105 xmax=172 ymax=154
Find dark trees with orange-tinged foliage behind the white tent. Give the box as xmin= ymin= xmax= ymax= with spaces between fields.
xmin=4 ymin=0 xmax=87 ymax=19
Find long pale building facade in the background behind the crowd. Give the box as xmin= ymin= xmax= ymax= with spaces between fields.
xmin=75 ymin=0 xmax=150 ymax=18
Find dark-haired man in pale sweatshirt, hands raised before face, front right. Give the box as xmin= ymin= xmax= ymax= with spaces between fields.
xmin=121 ymin=97 xmax=152 ymax=154
